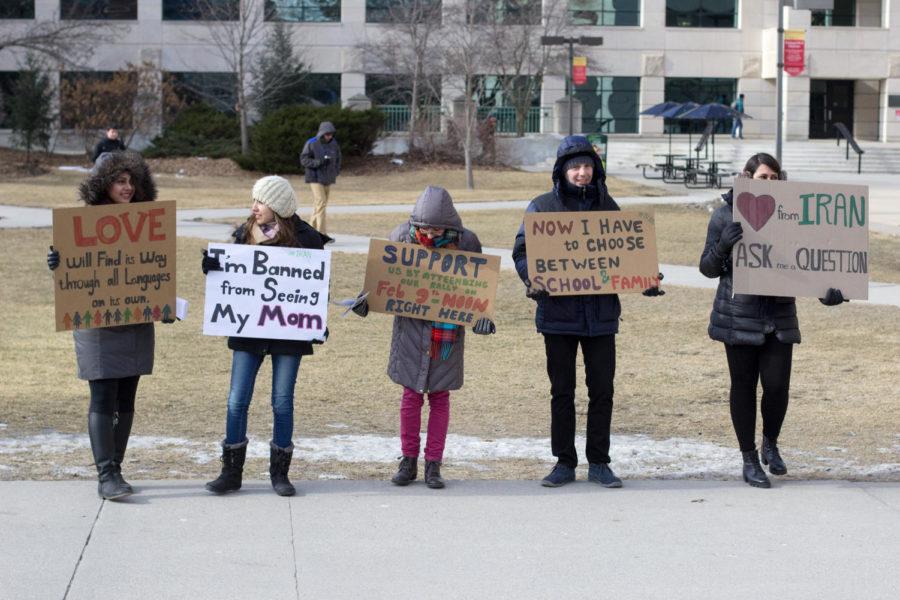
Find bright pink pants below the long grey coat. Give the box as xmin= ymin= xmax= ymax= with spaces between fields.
xmin=400 ymin=386 xmax=450 ymax=462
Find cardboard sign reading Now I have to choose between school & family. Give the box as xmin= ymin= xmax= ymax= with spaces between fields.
xmin=525 ymin=210 xmax=659 ymax=296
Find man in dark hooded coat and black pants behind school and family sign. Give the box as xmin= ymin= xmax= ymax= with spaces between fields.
xmin=513 ymin=135 xmax=664 ymax=487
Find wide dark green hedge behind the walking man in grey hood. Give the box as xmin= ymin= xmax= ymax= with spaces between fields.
xmin=234 ymin=105 xmax=384 ymax=174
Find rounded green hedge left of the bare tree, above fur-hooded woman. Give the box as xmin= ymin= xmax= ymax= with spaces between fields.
xmin=144 ymin=104 xmax=241 ymax=158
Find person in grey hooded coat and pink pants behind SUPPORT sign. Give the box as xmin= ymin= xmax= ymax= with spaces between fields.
xmin=353 ymin=186 xmax=496 ymax=489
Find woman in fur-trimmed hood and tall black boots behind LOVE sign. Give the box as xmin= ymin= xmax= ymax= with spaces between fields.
xmin=47 ymin=152 xmax=163 ymax=500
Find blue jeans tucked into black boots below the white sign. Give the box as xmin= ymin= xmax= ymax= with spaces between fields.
xmin=225 ymin=350 xmax=300 ymax=448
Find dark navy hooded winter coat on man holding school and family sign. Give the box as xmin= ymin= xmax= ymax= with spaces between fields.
xmin=513 ymin=136 xmax=622 ymax=337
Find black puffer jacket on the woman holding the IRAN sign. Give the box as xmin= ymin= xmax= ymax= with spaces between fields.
xmin=700 ymin=190 xmax=800 ymax=346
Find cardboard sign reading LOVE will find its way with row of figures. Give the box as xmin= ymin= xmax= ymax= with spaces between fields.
xmin=53 ymin=201 xmax=176 ymax=331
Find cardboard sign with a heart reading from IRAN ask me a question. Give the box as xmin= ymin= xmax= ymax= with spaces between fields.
xmin=731 ymin=177 xmax=869 ymax=299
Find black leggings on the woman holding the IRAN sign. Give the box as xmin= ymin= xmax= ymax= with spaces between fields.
xmin=725 ymin=333 xmax=793 ymax=452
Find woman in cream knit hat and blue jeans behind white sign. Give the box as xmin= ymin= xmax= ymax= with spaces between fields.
xmin=202 ymin=175 xmax=328 ymax=496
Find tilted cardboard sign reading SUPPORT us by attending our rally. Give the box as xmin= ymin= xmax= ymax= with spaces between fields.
xmin=365 ymin=240 xmax=500 ymax=327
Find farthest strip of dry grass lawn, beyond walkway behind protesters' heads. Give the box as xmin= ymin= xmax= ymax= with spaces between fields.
xmin=0 ymin=168 xmax=671 ymax=208
